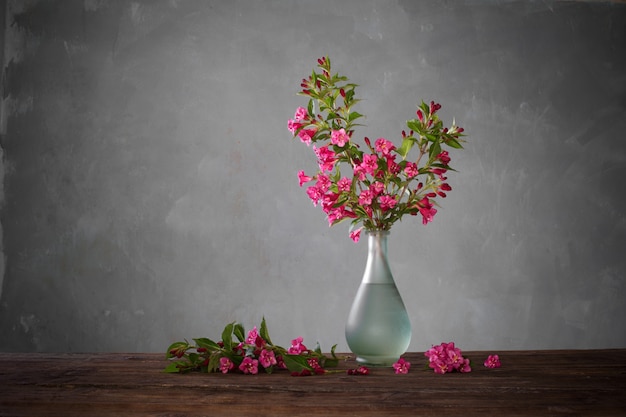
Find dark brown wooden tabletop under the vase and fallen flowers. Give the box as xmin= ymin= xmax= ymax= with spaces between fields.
xmin=0 ymin=349 xmax=626 ymax=417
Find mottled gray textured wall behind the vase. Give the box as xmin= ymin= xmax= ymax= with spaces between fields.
xmin=0 ymin=0 xmax=626 ymax=351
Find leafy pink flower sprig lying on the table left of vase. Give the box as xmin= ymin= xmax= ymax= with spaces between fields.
xmin=165 ymin=319 xmax=339 ymax=376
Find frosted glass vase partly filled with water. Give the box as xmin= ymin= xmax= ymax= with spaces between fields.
xmin=346 ymin=231 xmax=411 ymax=366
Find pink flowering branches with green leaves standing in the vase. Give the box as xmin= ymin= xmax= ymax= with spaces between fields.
xmin=288 ymin=57 xmax=464 ymax=242
